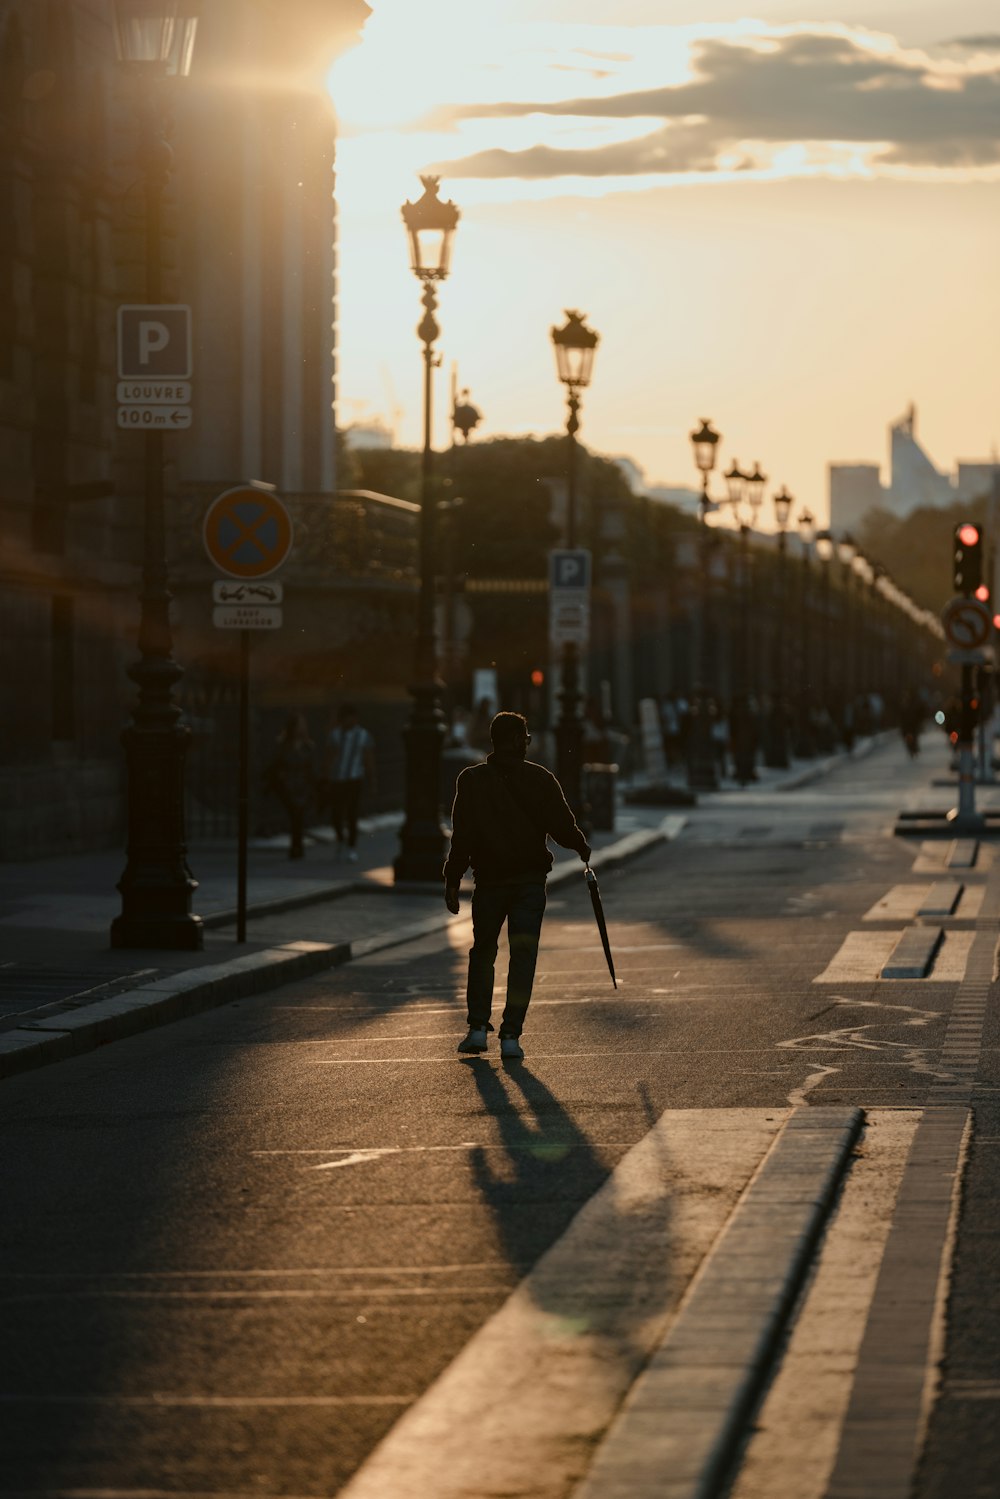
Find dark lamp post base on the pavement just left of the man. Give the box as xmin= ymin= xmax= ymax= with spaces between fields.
xmin=393 ymin=682 xmax=448 ymax=884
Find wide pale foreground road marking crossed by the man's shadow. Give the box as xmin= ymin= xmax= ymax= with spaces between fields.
xmin=340 ymin=1109 xmax=786 ymax=1499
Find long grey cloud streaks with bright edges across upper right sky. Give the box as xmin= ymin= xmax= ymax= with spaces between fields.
xmin=425 ymin=28 xmax=1000 ymax=178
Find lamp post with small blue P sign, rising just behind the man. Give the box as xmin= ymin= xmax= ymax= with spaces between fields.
xmin=552 ymin=310 xmax=600 ymax=812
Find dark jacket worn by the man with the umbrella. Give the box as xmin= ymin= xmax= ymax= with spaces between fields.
xmin=444 ymin=752 xmax=588 ymax=884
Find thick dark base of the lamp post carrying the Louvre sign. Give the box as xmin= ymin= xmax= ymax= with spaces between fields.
xmin=111 ymin=726 xmax=204 ymax=952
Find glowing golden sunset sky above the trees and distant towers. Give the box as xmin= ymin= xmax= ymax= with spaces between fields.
xmin=330 ymin=0 xmax=1000 ymax=523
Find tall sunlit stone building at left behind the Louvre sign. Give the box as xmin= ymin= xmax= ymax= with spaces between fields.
xmin=0 ymin=0 xmax=369 ymax=859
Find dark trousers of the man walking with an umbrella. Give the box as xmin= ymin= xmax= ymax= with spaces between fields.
xmin=466 ymin=880 xmax=546 ymax=1036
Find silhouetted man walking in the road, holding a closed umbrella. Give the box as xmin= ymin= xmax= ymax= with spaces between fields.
xmin=444 ymin=714 xmax=591 ymax=1058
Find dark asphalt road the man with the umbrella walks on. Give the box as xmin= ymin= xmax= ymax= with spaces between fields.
xmin=0 ymin=742 xmax=1000 ymax=1499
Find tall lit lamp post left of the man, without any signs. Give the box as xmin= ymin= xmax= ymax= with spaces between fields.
xmin=393 ymin=177 xmax=459 ymax=881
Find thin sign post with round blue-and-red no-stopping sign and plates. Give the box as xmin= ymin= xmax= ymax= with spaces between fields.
xmin=202 ymin=484 xmax=292 ymax=943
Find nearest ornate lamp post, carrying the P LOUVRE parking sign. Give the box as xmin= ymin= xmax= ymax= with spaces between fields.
xmin=111 ymin=0 xmax=204 ymax=950
